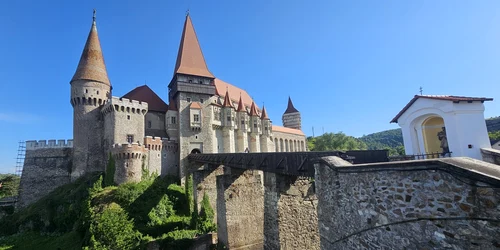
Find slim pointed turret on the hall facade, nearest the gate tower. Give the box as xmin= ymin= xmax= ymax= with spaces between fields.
xmin=221 ymin=90 xmax=235 ymax=153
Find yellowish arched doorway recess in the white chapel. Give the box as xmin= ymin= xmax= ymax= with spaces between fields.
xmin=422 ymin=116 xmax=449 ymax=157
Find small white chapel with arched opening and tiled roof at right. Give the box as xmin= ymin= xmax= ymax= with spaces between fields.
xmin=391 ymin=95 xmax=493 ymax=160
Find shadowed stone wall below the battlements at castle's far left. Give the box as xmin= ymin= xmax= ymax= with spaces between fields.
xmin=18 ymin=148 xmax=73 ymax=207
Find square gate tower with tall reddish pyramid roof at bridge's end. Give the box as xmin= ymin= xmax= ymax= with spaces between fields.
xmin=168 ymin=14 xmax=215 ymax=183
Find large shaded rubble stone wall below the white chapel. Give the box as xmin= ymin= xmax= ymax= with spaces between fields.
xmin=315 ymin=158 xmax=500 ymax=249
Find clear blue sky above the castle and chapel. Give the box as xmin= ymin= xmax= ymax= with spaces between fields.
xmin=0 ymin=0 xmax=500 ymax=173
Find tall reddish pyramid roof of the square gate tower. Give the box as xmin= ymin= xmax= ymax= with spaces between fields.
xmin=174 ymin=14 xmax=215 ymax=78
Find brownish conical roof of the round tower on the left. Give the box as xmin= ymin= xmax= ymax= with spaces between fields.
xmin=71 ymin=9 xmax=111 ymax=85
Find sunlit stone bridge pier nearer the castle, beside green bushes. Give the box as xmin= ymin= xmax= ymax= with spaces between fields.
xmin=217 ymin=168 xmax=264 ymax=250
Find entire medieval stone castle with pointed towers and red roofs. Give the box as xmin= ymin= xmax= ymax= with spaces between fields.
xmin=23 ymin=13 xmax=307 ymax=195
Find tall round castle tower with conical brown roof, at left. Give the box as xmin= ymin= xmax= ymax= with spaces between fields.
xmin=70 ymin=11 xmax=111 ymax=180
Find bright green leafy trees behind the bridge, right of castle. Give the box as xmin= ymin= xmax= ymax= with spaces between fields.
xmin=308 ymin=132 xmax=367 ymax=151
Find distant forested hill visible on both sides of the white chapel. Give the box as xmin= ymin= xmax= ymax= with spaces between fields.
xmin=358 ymin=117 xmax=500 ymax=149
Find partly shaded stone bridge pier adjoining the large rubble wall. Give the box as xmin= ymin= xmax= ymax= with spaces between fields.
xmin=264 ymin=172 xmax=320 ymax=249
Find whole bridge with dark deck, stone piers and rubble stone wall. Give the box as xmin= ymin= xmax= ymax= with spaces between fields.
xmin=188 ymin=152 xmax=500 ymax=249
